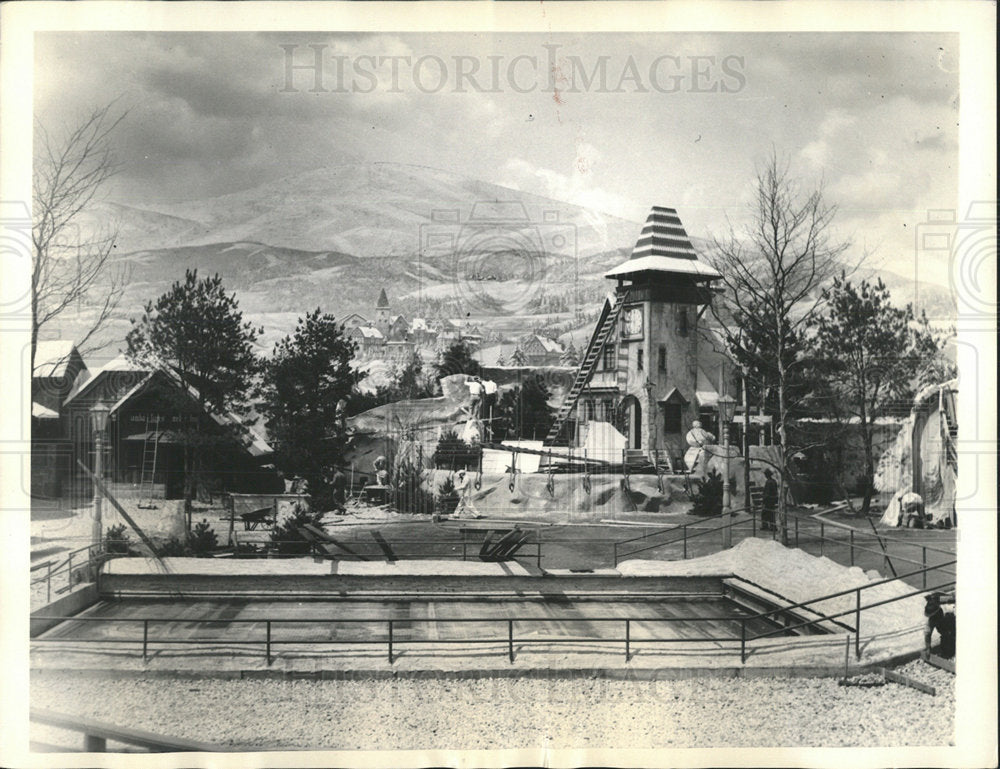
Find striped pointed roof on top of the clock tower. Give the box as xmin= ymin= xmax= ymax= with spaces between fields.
xmin=604 ymin=206 xmax=722 ymax=280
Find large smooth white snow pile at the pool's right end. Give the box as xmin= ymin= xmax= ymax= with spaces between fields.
xmin=618 ymin=539 xmax=924 ymax=635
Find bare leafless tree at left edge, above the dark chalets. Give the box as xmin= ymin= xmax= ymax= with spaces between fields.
xmin=31 ymin=102 xmax=126 ymax=372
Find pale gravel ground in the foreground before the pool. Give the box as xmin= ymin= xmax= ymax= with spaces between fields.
xmin=31 ymin=661 xmax=955 ymax=750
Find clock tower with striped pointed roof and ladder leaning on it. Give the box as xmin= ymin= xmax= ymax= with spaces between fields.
xmin=550 ymin=206 xmax=721 ymax=462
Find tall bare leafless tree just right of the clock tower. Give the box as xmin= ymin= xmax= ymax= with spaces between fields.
xmin=711 ymin=153 xmax=851 ymax=544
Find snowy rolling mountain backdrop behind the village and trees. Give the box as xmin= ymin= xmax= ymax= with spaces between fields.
xmin=56 ymin=163 xmax=954 ymax=362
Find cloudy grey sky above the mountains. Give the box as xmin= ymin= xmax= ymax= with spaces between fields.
xmin=35 ymin=32 xmax=959 ymax=285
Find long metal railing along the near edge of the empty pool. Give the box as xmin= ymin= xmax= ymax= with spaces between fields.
xmin=32 ymin=561 xmax=956 ymax=665
